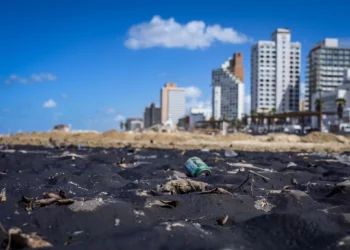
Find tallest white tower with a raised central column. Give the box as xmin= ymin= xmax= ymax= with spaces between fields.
xmin=251 ymin=29 xmax=301 ymax=113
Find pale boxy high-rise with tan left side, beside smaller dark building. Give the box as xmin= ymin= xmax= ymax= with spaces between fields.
xmin=160 ymin=83 xmax=186 ymax=125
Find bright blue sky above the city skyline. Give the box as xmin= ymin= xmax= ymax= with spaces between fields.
xmin=0 ymin=0 xmax=350 ymax=133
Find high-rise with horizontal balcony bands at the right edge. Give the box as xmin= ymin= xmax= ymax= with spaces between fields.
xmin=307 ymin=38 xmax=350 ymax=109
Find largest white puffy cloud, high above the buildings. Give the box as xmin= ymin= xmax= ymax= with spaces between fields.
xmin=124 ymin=16 xmax=250 ymax=49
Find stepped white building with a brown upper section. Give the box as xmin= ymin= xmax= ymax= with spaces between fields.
xmin=212 ymin=53 xmax=244 ymax=120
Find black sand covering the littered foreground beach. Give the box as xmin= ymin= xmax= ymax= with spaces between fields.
xmin=0 ymin=146 xmax=350 ymax=250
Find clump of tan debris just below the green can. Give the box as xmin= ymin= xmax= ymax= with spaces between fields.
xmin=157 ymin=179 xmax=208 ymax=194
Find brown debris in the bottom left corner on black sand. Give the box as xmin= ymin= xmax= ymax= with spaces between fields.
xmin=0 ymin=223 xmax=52 ymax=250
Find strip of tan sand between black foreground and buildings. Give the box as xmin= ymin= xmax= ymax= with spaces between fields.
xmin=0 ymin=130 xmax=350 ymax=152
